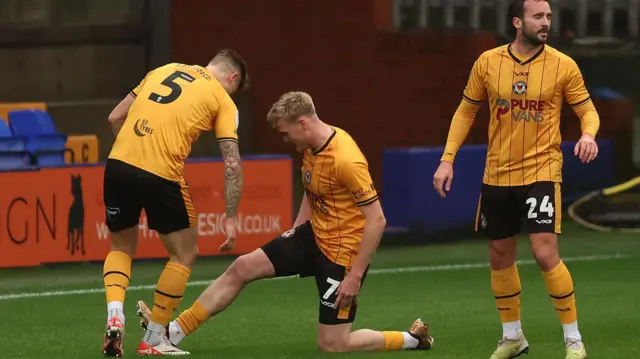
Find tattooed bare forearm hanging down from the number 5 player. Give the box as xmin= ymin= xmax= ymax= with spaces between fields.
xmin=220 ymin=141 xmax=242 ymax=218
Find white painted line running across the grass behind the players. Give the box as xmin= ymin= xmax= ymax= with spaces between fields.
xmin=0 ymin=254 xmax=629 ymax=301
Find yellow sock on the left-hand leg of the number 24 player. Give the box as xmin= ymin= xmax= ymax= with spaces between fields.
xmin=491 ymin=263 xmax=521 ymax=323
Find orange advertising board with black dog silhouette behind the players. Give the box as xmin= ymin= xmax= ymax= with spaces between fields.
xmin=0 ymin=156 xmax=293 ymax=267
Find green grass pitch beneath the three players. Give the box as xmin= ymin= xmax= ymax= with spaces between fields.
xmin=0 ymin=223 xmax=640 ymax=359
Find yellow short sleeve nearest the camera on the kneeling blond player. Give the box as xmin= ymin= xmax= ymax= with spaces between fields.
xmin=337 ymin=159 xmax=378 ymax=207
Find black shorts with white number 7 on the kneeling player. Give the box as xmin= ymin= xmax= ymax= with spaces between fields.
xmin=262 ymin=222 xmax=366 ymax=325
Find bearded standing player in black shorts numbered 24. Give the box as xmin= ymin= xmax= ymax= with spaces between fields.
xmin=433 ymin=0 xmax=600 ymax=359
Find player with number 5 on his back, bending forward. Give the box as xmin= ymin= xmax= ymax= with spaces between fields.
xmin=103 ymin=49 xmax=248 ymax=357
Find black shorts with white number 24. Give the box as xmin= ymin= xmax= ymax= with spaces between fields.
xmin=476 ymin=181 xmax=562 ymax=239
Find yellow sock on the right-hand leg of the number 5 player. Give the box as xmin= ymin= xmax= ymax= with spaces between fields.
xmin=151 ymin=262 xmax=191 ymax=326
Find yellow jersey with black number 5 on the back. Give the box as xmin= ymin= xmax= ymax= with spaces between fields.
xmin=109 ymin=63 xmax=239 ymax=181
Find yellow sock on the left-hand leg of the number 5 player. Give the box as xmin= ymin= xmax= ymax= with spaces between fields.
xmin=103 ymin=251 xmax=131 ymax=303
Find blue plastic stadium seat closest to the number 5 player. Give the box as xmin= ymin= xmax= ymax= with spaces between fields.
xmin=9 ymin=110 xmax=67 ymax=166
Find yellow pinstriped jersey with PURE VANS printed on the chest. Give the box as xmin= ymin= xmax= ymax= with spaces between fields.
xmin=442 ymin=44 xmax=599 ymax=186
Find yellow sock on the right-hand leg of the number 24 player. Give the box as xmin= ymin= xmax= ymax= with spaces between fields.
xmin=542 ymin=262 xmax=578 ymax=324
